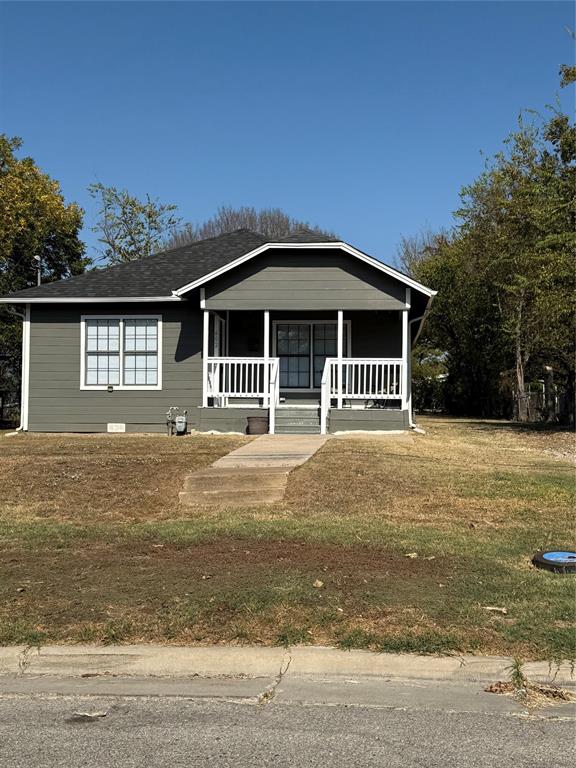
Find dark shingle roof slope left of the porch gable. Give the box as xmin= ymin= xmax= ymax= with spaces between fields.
xmin=5 ymin=229 xmax=267 ymax=301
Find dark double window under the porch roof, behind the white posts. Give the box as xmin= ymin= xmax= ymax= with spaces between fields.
xmin=274 ymin=321 xmax=348 ymax=392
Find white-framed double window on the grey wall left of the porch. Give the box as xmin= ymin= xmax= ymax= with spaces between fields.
xmin=80 ymin=316 xmax=162 ymax=389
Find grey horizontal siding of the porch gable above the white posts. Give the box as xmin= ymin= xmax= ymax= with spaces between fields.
xmin=205 ymin=250 xmax=406 ymax=310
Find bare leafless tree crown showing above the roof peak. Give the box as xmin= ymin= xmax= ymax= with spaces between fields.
xmin=166 ymin=206 xmax=335 ymax=248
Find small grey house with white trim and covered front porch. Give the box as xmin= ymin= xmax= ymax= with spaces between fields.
xmin=0 ymin=229 xmax=435 ymax=433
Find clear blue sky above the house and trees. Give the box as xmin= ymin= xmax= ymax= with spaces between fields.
xmin=0 ymin=2 xmax=575 ymax=262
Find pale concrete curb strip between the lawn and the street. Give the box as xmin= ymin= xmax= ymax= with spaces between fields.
xmin=0 ymin=645 xmax=576 ymax=686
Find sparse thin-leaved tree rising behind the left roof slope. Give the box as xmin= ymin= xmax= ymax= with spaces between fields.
xmin=88 ymin=183 xmax=181 ymax=264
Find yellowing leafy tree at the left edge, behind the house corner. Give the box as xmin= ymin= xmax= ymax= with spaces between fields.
xmin=0 ymin=134 xmax=88 ymax=416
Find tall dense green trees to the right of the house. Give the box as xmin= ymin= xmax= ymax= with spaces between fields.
xmin=401 ymin=73 xmax=576 ymax=421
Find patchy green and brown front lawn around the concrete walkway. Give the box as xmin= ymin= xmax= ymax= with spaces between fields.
xmin=0 ymin=419 xmax=576 ymax=659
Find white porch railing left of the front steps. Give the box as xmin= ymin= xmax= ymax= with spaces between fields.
xmin=204 ymin=357 xmax=280 ymax=434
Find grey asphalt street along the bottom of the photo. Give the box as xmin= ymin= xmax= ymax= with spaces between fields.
xmin=0 ymin=679 xmax=576 ymax=768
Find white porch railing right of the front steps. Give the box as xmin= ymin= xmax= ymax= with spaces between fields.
xmin=320 ymin=357 xmax=404 ymax=434
